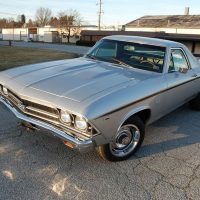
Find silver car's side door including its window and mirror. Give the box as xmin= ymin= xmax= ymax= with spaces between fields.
xmin=164 ymin=48 xmax=196 ymax=111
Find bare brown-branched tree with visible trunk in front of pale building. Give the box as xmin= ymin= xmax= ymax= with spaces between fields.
xmin=58 ymin=10 xmax=81 ymax=43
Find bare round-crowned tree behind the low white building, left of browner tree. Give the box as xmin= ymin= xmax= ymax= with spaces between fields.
xmin=35 ymin=7 xmax=52 ymax=26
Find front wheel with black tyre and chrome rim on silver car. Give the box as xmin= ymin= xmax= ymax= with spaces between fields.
xmin=97 ymin=116 xmax=145 ymax=161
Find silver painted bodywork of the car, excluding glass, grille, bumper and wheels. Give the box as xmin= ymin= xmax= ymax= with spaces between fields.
xmin=0 ymin=36 xmax=200 ymax=152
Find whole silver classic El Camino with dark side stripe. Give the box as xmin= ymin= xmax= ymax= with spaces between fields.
xmin=0 ymin=36 xmax=200 ymax=161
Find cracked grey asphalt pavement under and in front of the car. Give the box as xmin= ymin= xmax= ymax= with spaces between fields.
xmin=0 ymin=105 xmax=200 ymax=200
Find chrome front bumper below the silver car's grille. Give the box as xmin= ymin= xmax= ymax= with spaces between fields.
xmin=0 ymin=95 xmax=94 ymax=152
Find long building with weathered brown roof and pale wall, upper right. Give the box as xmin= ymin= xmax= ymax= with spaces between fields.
xmin=124 ymin=15 xmax=200 ymax=34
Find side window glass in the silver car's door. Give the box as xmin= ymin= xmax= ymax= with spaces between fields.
xmin=169 ymin=49 xmax=189 ymax=72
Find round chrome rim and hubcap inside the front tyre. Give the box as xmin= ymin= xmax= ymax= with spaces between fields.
xmin=110 ymin=124 xmax=140 ymax=157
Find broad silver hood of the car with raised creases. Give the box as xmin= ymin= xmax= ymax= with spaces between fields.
xmin=0 ymin=58 xmax=152 ymax=102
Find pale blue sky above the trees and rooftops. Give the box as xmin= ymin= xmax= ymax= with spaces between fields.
xmin=0 ymin=0 xmax=200 ymax=25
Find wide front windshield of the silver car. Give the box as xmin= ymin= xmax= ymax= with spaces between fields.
xmin=86 ymin=39 xmax=166 ymax=73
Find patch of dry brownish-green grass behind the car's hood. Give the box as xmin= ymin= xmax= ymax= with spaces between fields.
xmin=0 ymin=46 xmax=77 ymax=71
